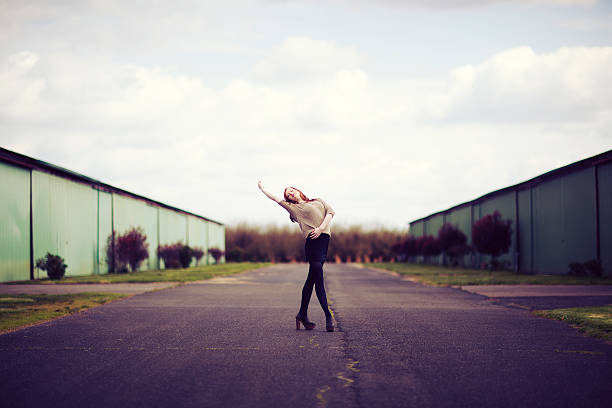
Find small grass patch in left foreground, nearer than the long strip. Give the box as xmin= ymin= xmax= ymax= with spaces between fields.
xmin=0 ymin=292 xmax=131 ymax=334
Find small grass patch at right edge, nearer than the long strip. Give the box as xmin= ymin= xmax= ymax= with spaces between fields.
xmin=532 ymin=305 xmax=612 ymax=342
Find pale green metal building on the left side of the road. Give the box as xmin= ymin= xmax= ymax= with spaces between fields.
xmin=0 ymin=148 xmax=225 ymax=282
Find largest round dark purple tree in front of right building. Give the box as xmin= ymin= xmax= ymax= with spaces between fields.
xmin=472 ymin=210 xmax=512 ymax=268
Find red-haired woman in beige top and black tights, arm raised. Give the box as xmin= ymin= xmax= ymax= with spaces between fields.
xmin=257 ymin=181 xmax=335 ymax=332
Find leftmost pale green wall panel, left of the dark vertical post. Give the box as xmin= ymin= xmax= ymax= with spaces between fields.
xmin=0 ymin=162 xmax=30 ymax=281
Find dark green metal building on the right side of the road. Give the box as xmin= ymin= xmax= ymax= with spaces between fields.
xmin=410 ymin=150 xmax=612 ymax=276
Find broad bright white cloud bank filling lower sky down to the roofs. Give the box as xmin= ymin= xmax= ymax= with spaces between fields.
xmin=0 ymin=37 xmax=612 ymax=226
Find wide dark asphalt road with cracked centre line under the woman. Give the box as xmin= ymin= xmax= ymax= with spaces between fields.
xmin=0 ymin=265 xmax=612 ymax=408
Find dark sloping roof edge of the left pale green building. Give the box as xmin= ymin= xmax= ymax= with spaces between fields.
xmin=0 ymin=147 xmax=223 ymax=225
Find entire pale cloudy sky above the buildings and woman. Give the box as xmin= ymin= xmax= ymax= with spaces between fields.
xmin=0 ymin=0 xmax=612 ymax=229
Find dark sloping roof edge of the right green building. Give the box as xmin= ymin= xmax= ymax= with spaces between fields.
xmin=409 ymin=150 xmax=612 ymax=225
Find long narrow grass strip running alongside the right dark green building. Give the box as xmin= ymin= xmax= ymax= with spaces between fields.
xmin=363 ymin=263 xmax=612 ymax=286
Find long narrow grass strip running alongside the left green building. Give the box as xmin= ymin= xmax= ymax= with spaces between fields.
xmin=11 ymin=262 xmax=270 ymax=285
